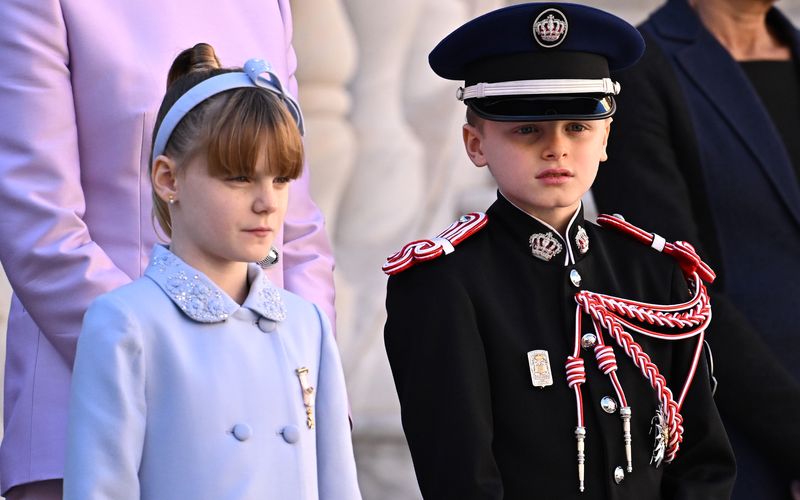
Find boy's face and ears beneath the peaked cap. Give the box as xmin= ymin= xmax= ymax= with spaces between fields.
xmin=463 ymin=118 xmax=611 ymax=230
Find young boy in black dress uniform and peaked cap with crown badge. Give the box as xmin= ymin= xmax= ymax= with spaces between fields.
xmin=384 ymin=3 xmax=735 ymax=500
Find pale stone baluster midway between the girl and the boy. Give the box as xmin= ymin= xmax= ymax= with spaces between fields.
xmin=334 ymin=0 xmax=425 ymax=494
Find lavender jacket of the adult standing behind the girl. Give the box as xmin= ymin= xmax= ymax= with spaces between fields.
xmin=0 ymin=0 xmax=333 ymax=493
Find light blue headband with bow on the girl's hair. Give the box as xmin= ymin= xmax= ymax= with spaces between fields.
xmin=150 ymin=59 xmax=305 ymax=162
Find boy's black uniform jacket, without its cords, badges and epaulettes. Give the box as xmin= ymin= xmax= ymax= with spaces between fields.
xmin=385 ymin=196 xmax=735 ymax=500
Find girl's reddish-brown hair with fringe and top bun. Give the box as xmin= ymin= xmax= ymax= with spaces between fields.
xmin=150 ymin=43 xmax=303 ymax=237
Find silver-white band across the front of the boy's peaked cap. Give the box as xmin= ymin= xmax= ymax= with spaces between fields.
xmin=456 ymin=78 xmax=621 ymax=101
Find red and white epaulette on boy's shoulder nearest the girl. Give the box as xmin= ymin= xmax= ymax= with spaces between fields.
xmin=381 ymin=212 xmax=489 ymax=276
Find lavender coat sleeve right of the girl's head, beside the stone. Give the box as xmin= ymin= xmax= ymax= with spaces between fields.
xmin=272 ymin=0 xmax=336 ymax=332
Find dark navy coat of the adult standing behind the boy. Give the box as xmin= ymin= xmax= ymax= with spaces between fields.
xmin=592 ymin=0 xmax=800 ymax=499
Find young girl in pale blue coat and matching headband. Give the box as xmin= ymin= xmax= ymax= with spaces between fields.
xmin=64 ymin=44 xmax=360 ymax=500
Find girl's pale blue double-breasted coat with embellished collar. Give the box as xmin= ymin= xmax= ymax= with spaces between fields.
xmin=64 ymin=246 xmax=361 ymax=500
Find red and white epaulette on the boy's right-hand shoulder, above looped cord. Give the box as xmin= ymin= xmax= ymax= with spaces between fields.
xmin=597 ymin=214 xmax=717 ymax=283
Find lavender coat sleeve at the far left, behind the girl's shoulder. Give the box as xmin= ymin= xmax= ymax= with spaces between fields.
xmin=0 ymin=0 xmax=130 ymax=363
